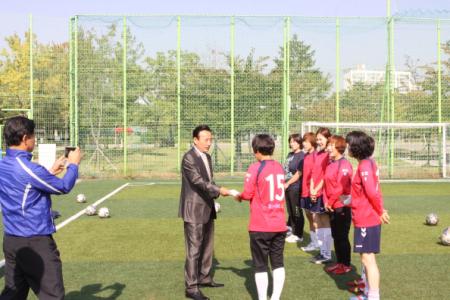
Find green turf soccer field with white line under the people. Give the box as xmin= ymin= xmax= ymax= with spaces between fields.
xmin=0 ymin=180 xmax=450 ymax=300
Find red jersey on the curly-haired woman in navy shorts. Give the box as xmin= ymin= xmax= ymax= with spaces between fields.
xmin=351 ymin=159 xmax=384 ymax=227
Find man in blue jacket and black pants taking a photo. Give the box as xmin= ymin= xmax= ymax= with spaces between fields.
xmin=0 ymin=117 xmax=81 ymax=300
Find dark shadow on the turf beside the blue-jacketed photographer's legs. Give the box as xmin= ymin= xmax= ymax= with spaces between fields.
xmin=65 ymin=282 xmax=126 ymax=300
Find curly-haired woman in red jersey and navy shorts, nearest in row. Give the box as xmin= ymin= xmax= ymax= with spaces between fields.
xmin=346 ymin=131 xmax=389 ymax=300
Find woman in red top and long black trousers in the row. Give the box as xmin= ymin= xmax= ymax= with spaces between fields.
xmin=324 ymin=135 xmax=353 ymax=275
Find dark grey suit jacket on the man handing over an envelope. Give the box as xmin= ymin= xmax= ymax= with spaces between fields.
xmin=178 ymin=147 xmax=220 ymax=224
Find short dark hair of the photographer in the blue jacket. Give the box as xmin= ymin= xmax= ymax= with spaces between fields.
xmin=3 ymin=116 xmax=35 ymax=147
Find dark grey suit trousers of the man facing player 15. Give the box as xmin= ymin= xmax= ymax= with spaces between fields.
xmin=184 ymin=219 xmax=214 ymax=292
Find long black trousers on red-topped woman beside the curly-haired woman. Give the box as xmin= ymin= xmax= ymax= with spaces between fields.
xmin=330 ymin=207 xmax=352 ymax=266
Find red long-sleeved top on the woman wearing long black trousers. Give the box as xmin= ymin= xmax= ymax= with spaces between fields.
xmin=324 ymin=157 xmax=353 ymax=209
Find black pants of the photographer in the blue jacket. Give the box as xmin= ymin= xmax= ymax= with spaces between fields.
xmin=0 ymin=235 xmax=64 ymax=300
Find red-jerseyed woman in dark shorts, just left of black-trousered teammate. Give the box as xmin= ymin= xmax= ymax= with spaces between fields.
xmin=307 ymin=128 xmax=333 ymax=264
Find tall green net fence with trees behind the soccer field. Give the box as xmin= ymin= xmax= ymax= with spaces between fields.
xmin=0 ymin=16 xmax=450 ymax=178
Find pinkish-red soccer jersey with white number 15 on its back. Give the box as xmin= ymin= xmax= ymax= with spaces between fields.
xmin=241 ymin=160 xmax=286 ymax=232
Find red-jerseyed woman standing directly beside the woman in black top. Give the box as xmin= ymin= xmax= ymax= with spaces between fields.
xmin=300 ymin=132 xmax=319 ymax=252
